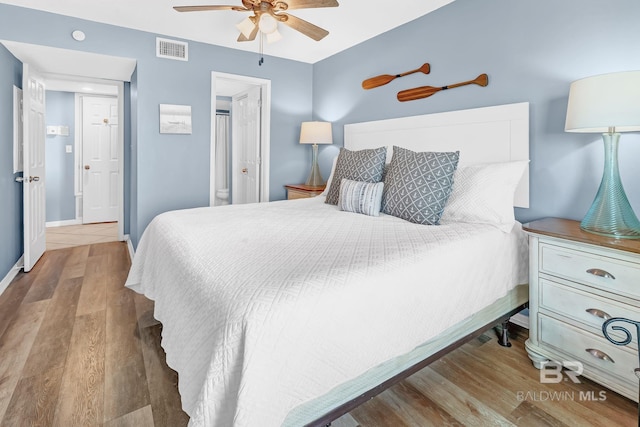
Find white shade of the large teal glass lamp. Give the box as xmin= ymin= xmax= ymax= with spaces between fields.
xmin=565 ymin=71 xmax=640 ymax=133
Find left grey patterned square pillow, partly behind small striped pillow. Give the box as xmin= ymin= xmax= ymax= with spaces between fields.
xmin=325 ymin=147 xmax=387 ymax=205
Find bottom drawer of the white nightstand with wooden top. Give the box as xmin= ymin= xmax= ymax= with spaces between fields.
xmin=539 ymin=314 xmax=638 ymax=386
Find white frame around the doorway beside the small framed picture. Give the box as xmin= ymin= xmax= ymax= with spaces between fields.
xmin=209 ymin=71 xmax=271 ymax=206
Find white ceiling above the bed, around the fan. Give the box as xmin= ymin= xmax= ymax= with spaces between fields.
xmin=2 ymin=0 xmax=453 ymax=64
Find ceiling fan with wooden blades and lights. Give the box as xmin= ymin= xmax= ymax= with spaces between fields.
xmin=174 ymin=0 xmax=339 ymax=42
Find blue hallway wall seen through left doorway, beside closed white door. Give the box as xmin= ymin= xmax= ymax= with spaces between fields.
xmin=45 ymin=90 xmax=76 ymax=222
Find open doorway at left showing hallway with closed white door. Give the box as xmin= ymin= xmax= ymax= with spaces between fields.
xmin=45 ymin=79 xmax=120 ymax=250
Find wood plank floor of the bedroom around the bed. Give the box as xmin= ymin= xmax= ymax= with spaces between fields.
xmin=0 ymin=242 xmax=637 ymax=427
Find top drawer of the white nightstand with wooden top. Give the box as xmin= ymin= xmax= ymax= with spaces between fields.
xmin=539 ymin=244 xmax=640 ymax=299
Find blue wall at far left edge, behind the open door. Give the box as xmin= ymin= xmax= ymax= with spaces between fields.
xmin=0 ymin=45 xmax=22 ymax=280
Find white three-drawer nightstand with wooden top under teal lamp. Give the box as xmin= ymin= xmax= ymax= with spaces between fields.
xmin=523 ymin=218 xmax=640 ymax=401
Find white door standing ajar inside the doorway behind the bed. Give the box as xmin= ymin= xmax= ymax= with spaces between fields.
xmin=231 ymin=86 xmax=262 ymax=204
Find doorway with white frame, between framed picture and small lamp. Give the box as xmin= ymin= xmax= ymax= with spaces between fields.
xmin=209 ymin=72 xmax=271 ymax=206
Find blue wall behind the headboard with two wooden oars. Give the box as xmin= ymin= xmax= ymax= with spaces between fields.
xmin=313 ymin=0 xmax=640 ymax=221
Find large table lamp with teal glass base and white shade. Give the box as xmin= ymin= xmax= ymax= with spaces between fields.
xmin=565 ymin=71 xmax=640 ymax=239
